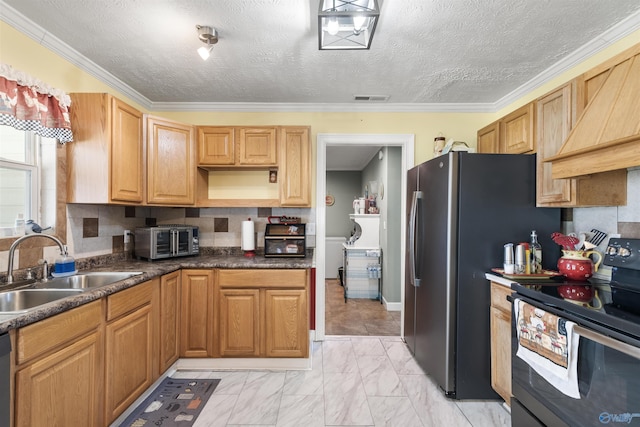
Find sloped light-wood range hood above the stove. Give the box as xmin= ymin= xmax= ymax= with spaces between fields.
xmin=545 ymin=45 xmax=640 ymax=179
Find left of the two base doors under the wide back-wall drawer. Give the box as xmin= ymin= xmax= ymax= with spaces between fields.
xmin=220 ymin=289 xmax=260 ymax=357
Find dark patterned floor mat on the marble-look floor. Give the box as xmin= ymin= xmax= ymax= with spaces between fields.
xmin=120 ymin=378 xmax=220 ymax=427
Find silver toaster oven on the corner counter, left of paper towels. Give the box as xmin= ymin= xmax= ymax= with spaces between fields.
xmin=134 ymin=225 xmax=200 ymax=260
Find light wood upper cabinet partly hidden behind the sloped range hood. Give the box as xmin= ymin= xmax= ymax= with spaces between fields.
xmin=536 ymin=79 xmax=627 ymax=207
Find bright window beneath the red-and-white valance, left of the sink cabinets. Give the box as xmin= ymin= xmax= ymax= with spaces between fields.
xmin=0 ymin=126 xmax=57 ymax=237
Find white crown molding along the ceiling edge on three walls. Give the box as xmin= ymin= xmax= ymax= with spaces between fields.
xmin=5 ymin=4 xmax=640 ymax=113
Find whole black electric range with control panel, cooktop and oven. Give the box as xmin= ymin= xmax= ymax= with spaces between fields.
xmin=511 ymin=239 xmax=640 ymax=427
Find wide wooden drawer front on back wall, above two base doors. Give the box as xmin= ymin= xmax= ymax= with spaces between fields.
xmin=218 ymin=269 xmax=307 ymax=289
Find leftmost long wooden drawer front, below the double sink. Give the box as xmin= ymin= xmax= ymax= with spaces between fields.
xmin=16 ymin=300 xmax=102 ymax=364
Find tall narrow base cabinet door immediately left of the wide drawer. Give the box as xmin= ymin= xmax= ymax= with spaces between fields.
xmin=180 ymin=270 xmax=214 ymax=357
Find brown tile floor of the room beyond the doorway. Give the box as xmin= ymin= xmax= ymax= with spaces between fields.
xmin=325 ymin=279 xmax=400 ymax=336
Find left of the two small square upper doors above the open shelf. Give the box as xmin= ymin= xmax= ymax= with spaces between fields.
xmin=198 ymin=126 xmax=236 ymax=166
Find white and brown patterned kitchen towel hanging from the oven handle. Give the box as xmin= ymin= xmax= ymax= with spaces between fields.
xmin=514 ymin=299 xmax=580 ymax=399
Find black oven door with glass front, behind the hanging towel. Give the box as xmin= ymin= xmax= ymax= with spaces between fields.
xmin=511 ymin=295 xmax=640 ymax=427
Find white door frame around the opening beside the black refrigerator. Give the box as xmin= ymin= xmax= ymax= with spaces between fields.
xmin=314 ymin=134 xmax=414 ymax=340
